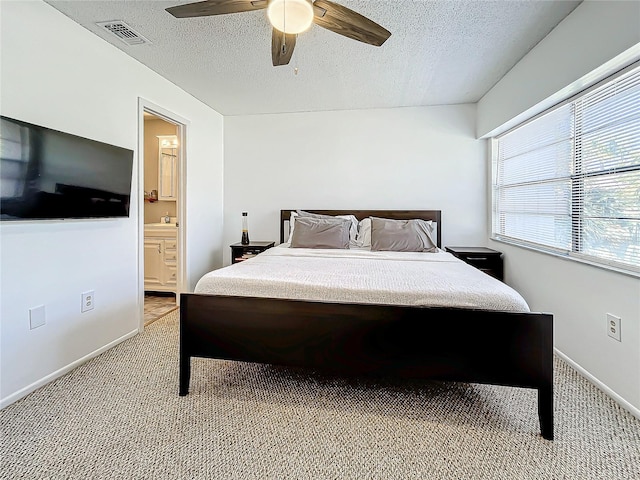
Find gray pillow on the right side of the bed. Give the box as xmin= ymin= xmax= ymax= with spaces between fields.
xmin=371 ymin=217 xmax=438 ymax=252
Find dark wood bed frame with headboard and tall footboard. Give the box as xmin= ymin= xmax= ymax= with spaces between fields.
xmin=180 ymin=210 xmax=553 ymax=440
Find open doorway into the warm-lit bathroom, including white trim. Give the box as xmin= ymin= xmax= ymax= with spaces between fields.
xmin=138 ymin=99 xmax=187 ymax=331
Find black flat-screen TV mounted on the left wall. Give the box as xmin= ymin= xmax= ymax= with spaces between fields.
xmin=0 ymin=116 xmax=133 ymax=221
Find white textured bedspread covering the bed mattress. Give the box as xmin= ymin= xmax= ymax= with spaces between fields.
xmin=195 ymin=244 xmax=529 ymax=312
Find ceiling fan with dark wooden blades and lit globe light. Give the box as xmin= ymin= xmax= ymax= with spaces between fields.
xmin=166 ymin=0 xmax=391 ymax=67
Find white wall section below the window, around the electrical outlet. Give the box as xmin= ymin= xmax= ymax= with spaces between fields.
xmin=504 ymin=242 xmax=640 ymax=417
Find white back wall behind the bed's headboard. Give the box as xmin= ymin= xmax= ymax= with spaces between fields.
xmin=224 ymin=105 xmax=487 ymax=264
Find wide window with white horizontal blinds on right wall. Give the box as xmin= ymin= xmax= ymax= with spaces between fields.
xmin=492 ymin=67 xmax=640 ymax=274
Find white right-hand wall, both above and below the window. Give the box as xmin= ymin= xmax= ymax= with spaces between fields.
xmin=478 ymin=1 xmax=640 ymax=417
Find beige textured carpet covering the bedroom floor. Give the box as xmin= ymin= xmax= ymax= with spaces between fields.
xmin=0 ymin=311 xmax=640 ymax=480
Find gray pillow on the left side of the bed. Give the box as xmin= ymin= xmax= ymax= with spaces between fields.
xmin=291 ymin=217 xmax=351 ymax=248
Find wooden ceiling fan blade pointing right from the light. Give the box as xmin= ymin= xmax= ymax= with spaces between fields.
xmin=313 ymin=0 xmax=391 ymax=47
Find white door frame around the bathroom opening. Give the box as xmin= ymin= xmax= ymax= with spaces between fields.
xmin=137 ymin=97 xmax=190 ymax=332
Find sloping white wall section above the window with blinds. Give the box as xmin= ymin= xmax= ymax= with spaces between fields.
xmin=477 ymin=0 xmax=640 ymax=137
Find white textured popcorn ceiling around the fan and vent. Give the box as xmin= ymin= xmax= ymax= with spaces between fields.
xmin=46 ymin=0 xmax=580 ymax=115
